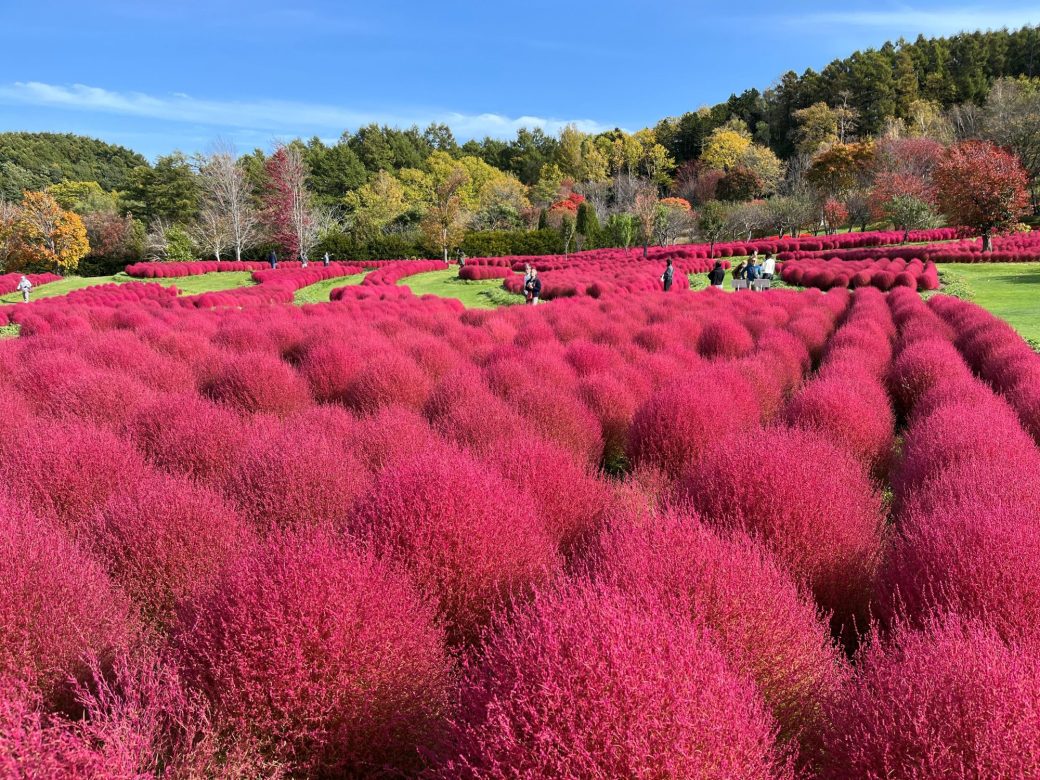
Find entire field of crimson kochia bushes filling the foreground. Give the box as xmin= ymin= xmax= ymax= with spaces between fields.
xmin=0 ymin=245 xmax=1040 ymax=780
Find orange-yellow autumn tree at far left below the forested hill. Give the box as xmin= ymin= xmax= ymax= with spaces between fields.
xmin=7 ymin=191 xmax=90 ymax=276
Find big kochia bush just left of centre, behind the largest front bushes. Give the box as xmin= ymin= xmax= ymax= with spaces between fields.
xmin=356 ymin=446 xmax=560 ymax=640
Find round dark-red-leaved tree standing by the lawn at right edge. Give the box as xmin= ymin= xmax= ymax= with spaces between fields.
xmin=932 ymin=140 xmax=1029 ymax=252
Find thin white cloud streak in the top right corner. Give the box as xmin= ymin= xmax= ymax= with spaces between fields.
xmin=788 ymin=4 xmax=1040 ymax=35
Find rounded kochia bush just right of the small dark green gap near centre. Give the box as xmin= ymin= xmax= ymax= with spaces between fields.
xmin=629 ymin=368 xmax=760 ymax=477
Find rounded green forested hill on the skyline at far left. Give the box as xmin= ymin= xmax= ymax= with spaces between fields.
xmin=0 ymin=133 xmax=148 ymax=199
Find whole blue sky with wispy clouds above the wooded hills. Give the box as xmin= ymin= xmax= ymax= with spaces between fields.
xmin=0 ymin=0 xmax=1040 ymax=157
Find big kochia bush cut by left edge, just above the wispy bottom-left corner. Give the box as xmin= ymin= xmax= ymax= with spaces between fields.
xmin=0 ymin=496 xmax=130 ymax=698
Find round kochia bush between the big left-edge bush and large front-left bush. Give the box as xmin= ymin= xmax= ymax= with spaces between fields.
xmin=92 ymin=475 xmax=250 ymax=627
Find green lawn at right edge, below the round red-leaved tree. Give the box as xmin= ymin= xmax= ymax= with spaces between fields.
xmin=939 ymin=263 xmax=1040 ymax=341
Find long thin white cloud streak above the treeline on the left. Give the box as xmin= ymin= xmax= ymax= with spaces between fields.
xmin=0 ymin=81 xmax=609 ymax=138
